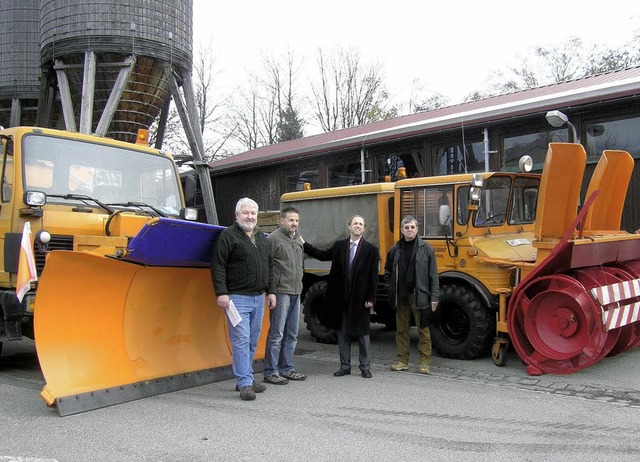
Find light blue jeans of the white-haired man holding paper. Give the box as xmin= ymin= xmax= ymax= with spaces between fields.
xmin=227 ymin=295 xmax=264 ymax=388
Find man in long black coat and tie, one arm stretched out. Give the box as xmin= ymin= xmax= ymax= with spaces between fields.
xmin=304 ymin=215 xmax=380 ymax=378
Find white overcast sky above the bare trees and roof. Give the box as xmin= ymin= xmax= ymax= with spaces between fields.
xmin=193 ymin=0 xmax=640 ymax=109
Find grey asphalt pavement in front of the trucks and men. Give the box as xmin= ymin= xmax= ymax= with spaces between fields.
xmin=0 ymin=326 xmax=640 ymax=462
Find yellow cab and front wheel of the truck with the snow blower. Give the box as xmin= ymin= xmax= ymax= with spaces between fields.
xmin=395 ymin=172 xmax=540 ymax=359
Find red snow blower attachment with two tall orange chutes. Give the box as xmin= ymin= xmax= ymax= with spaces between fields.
xmin=507 ymin=143 xmax=640 ymax=375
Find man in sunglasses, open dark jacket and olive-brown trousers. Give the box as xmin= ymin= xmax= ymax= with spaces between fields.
xmin=384 ymin=216 xmax=440 ymax=374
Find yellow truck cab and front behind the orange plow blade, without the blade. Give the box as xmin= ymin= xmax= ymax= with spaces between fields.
xmin=0 ymin=127 xmax=195 ymax=347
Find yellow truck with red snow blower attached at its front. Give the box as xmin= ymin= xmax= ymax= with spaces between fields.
xmin=281 ymin=143 xmax=640 ymax=374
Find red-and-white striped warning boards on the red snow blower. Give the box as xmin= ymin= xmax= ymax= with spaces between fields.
xmin=591 ymin=279 xmax=640 ymax=331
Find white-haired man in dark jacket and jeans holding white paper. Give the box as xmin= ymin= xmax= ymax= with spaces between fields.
xmin=211 ymin=197 xmax=276 ymax=401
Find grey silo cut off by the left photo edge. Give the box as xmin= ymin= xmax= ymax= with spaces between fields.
xmin=0 ymin=0 xmax=40 ymax=127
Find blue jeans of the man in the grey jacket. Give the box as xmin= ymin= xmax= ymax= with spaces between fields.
xmin=264 ymin=294 xmax=300 ymax=376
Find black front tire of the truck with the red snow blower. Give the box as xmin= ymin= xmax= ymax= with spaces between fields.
xmin=430 ymin=282 xmax=495 ymax=359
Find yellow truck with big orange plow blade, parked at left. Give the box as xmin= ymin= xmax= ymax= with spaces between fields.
xmin=0 ymin=127 xmax=254 ymax=415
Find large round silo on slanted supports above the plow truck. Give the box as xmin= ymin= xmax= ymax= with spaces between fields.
xmin=40 ymin=0 xmax=192 ymax=141
